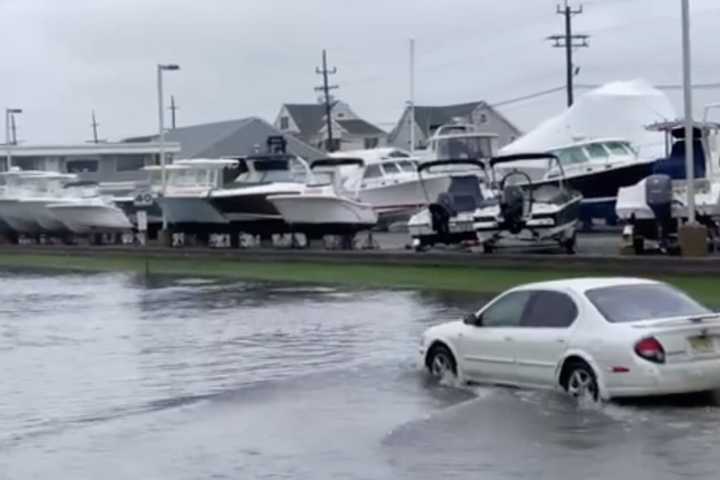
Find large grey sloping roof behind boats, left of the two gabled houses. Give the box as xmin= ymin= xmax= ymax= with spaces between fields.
xmin=126 ymin=117 xmax=325 ymax=160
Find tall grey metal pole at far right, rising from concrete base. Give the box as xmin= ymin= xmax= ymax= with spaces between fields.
xmin=682 ymin=0 xmax=695 ymax=224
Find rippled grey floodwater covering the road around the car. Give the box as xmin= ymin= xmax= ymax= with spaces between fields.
xmin=0 ymin=272 xmax=720 ymax=480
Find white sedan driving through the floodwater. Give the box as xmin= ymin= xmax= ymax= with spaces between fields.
xmin=419 ymin=278 xmax=720 ymax=399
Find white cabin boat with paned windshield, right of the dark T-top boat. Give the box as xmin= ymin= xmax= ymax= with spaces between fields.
xmin=331 ymin=148 xmax=451 ymax=220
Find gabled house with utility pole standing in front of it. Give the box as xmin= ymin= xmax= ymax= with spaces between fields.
xmin=275 ymin=101 xmax=387 ymax=151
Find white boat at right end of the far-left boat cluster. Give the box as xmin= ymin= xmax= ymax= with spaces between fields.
xmin=46 ymin=182 xmax=133 ymax=234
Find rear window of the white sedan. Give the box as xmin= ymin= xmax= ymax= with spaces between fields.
xmin=585 ymin=283 xmax=711 ymax=323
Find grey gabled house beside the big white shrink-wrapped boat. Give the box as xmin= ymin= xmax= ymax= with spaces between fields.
xmin=388 ymin=102 xmax=521 ymax=150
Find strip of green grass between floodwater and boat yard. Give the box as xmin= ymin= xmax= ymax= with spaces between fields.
xmin=0 ymin=254 xmax=720 ymax=305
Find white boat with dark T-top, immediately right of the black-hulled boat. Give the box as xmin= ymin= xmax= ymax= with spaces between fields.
xmin=268 ymin=158 xmax=378 ymax=238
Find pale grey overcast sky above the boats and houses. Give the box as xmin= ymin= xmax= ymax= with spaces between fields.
xmin=0 ymin=0 xmax=720 ymax=143
